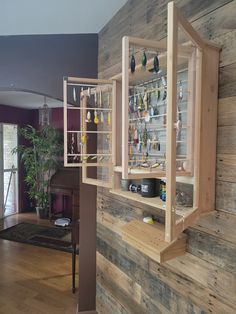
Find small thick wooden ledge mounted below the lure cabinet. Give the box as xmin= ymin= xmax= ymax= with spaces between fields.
xmin=122 ymin=220 xmax=186 ymax=263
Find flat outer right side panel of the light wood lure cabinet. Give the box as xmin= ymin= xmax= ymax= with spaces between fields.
xmin=199 ymin=46 xmax=219 ymax=212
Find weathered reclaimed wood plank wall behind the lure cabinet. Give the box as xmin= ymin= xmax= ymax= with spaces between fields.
xmin=97 ymin=0 xmax=236 ymax=314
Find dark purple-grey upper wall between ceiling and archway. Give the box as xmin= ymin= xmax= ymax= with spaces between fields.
xmin=0 ymin=34 xmax=98 ymax=99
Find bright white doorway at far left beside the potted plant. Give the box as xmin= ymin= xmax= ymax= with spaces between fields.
xmin=0 ymin=123 xmax=19 ymax=218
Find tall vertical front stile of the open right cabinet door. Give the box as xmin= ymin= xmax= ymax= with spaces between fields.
xmin=165 ymin=2 xmax=178 ymax=242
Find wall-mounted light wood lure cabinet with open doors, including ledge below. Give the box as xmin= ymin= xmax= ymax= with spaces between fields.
xmin=64 ymin=2 xmax=219 ymax=262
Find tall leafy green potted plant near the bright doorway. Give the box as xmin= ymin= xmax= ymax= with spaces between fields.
xmin=13 ymin=125 xmax=63 ymax=218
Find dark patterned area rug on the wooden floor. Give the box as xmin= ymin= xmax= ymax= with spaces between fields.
xmin=0 ymin=222 xmax=78 ymax=253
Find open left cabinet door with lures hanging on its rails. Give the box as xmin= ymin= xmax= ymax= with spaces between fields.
xmin=64 ymin=77 xmax=116 ymax=188
